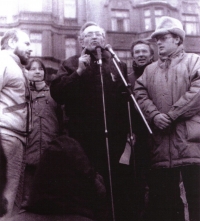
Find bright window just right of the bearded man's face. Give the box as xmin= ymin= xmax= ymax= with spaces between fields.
xmin=30 ymin=33 xmax=42 ymax=56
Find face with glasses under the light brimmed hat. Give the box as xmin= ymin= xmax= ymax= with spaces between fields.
xmin=156 ymin=34 xmax=179 ymax=56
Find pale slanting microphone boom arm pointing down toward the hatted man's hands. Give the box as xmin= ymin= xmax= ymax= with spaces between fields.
xmin=112 ymin=55 xmax=153 ymax=135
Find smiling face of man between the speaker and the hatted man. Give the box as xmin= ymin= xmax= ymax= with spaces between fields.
xmin=133 ymin=43 xmax=153 ymax=67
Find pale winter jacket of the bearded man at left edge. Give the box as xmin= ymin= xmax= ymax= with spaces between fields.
xmin=0 ymin=50 xmax=31 ymax=142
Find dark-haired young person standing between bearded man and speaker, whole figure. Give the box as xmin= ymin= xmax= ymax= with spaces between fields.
xmin=21 ymin=58 xmax=63 ymax=209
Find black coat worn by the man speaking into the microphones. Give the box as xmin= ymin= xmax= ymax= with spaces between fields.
xmin=50 ymin=50 xmax=128 ymax=172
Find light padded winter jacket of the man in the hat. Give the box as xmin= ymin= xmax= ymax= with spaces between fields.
xmin=134 ymin=46 xmax=200 ymax=168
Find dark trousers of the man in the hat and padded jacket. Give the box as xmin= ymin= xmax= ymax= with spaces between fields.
xmin=145 ymin=165 xmax=200 ymax=221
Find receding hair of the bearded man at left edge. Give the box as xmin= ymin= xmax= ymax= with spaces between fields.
xmin=1 ymin=28 xmax=20 ymax=50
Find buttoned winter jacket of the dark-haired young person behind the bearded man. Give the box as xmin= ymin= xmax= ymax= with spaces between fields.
xmin=26 ymin=85 xmax=62 ymax=165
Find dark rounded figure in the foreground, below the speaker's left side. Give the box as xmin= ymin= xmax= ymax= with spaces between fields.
xmin=28 ymin=135 xmax=106 ymax=219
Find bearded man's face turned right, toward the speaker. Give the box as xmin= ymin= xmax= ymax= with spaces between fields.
xmin=14 ymin=32 xmax=32 ymax=65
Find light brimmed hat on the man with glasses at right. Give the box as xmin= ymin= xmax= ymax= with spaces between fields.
xmin=151 ymin=16 xmax=185 ymax=39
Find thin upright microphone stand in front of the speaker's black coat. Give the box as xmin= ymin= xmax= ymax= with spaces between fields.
xmin=98 ymin=59 xmax=115 ymax=221
